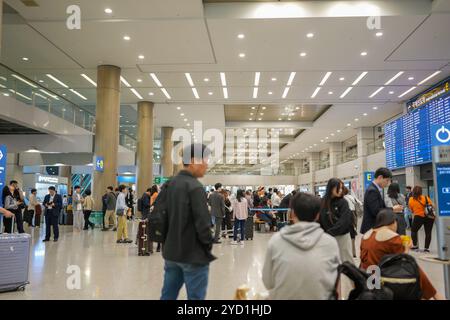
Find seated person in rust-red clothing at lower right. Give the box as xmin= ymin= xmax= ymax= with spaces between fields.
xmin=360 ymin=209 xmax=444 ymax=300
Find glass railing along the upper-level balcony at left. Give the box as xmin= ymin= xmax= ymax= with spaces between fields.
xmin=0 ymin=64 xmax=136 ymax=151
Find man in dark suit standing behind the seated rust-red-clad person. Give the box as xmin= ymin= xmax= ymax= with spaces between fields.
xmin=360 ymin=168 xmax=403 ymax=234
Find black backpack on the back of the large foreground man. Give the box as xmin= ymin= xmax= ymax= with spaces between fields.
xmin=148 ymin=181 xmax=170 ymax=243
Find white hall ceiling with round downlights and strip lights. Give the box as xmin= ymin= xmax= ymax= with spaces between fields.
xmin=1 ymin=0 xmax=450 ymax=165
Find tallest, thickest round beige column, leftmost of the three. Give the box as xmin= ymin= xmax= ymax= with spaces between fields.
xmin=92 ymin=65 xmax=120 ymax=210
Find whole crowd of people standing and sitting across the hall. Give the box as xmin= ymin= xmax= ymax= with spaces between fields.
xmin=0 ymin=144 xmax=443 ymax=299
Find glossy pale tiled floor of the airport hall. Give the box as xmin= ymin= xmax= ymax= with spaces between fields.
xmin=0 ymin=223 xmax=444 ymax=300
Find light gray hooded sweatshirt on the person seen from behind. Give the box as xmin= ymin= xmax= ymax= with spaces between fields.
xmin=262 ymin=222 xmax=340 ymax=300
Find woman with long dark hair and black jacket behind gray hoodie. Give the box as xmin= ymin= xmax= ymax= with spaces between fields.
xmin=320 ymin=178 xmax=354 ymax=263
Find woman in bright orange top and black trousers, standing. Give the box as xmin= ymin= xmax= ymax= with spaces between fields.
xmin=408 ymin=186 xmax=435 ymax=252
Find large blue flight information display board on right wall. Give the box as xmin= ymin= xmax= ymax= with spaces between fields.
xmin=385 ymin=80 xmax=450 ymax=169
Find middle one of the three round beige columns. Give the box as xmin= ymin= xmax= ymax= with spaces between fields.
xmin=136 ymin=101 xmax=153 ymax=197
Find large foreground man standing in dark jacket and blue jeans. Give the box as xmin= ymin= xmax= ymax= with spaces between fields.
xmin=161 ymin=144 xmax=215 ymax=300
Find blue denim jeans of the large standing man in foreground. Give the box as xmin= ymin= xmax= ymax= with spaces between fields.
xmin=161 ymin=260 xmax=209 ymax=300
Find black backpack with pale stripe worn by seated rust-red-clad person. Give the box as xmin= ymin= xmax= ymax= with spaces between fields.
xmin=378 ymin=253 xmax=422 ymax=300
